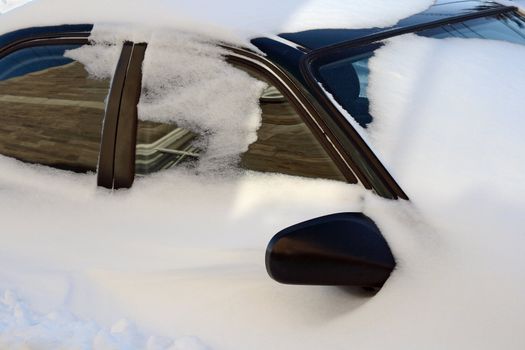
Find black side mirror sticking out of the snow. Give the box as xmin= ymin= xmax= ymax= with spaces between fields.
xmin=266 ymin=213 xmax=396 ymax=288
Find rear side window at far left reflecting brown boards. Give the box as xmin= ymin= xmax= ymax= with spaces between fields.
xmin=0 ymin=44 xmax=110 ymax=172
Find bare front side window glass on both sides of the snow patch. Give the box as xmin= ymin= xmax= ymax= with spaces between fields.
xmin=135 ymin=64 xmax=346 ymax=181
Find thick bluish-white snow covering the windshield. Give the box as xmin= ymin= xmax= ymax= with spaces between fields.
xmin=368 ymin=36 xmax=525 ymax=200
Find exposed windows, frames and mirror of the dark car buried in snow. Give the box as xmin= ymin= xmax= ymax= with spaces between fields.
xmin=0 ymin=0 xmax=525 ymax=348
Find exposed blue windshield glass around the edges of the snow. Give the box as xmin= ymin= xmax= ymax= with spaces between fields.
xmin=314 ymin=12 xmax=525 ymax=128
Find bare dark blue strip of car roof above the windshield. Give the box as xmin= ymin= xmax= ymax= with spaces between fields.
xmin=279 ymin=0 xmax=506 ymax=50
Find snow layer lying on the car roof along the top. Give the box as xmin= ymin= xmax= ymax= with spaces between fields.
xmin=0 ymin=0 xmax=433 ymax=43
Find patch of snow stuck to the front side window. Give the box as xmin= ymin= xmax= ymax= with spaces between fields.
xmin=137 ymin=31 xmax=266 ymax=171
